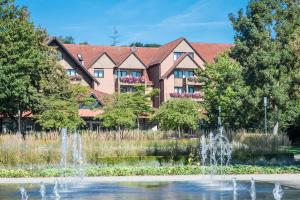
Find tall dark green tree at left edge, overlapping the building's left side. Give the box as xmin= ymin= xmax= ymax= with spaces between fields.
xmin=0 ymin=0 xmax=69 ymax=134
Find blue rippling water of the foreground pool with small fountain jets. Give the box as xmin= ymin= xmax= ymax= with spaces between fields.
xmin=0 ymin=181 xmax=300 ymax=200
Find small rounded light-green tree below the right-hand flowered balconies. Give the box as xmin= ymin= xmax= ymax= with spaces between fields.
xmin=152 ymin=98 xmax=205 ymax=133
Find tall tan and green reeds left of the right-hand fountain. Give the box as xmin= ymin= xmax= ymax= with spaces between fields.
xmin=0 ymin=131 xmax=198 ymax=166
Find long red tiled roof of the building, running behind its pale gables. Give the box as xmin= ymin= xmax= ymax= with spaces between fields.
xmin=64 ymin=37 xmax=233 ymax=68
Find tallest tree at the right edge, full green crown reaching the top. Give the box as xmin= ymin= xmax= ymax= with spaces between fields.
xmin=230 ymin=0 xmax=300 ymax=134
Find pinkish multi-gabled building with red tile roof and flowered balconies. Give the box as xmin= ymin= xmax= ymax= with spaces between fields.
xmin=1 ymin=37 xmax=232 ymax=130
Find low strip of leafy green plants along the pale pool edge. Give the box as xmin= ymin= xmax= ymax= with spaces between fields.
xmin=0 ymin=165 xmax=300 ymax=178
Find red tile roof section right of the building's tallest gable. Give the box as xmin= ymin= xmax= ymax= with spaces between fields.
xmin=191 ymin=42 xmax=234 ymax=63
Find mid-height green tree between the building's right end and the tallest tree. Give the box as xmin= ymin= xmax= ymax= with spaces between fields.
xmin=197 ymin=52 xmax=249 ymax=129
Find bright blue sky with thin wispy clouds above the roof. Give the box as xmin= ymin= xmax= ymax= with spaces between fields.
xmin=16 ymin=0 xmax=248 ymax=45
